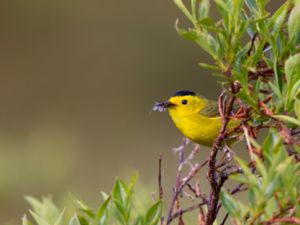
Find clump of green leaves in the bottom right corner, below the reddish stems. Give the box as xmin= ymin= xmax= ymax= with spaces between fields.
xmin=221 ymin=130 xmax=300 ymax=225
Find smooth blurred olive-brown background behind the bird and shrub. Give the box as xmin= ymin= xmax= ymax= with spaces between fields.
xmin=0 ymin=0 xmax=284 ymax=224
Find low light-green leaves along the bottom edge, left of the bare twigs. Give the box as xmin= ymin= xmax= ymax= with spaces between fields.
xmin=22 ymin=175 xmax=162 ymax=225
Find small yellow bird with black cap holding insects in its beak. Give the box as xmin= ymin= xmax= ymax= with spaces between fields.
xmin=153 ymin=90 xmax=239 ymax=147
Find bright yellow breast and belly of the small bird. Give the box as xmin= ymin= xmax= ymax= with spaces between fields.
xmin=169 ymin=110 xmax=222 ymax=146
